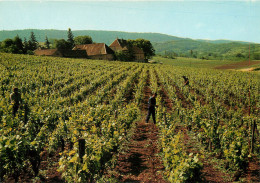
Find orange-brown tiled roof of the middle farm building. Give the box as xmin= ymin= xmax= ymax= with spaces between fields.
xmin=73 ymin=43 xmax=114 ymax=56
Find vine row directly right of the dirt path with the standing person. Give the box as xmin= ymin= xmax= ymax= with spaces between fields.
xmin=150 ymin=68 xmax=202 ymax=182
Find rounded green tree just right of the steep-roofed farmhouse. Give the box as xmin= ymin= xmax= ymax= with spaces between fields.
xmin=127 ymin=39 xmax=155 ymax=59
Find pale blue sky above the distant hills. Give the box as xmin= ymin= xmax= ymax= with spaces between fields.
xmin=0 ymin=0 xmax=260 ymax=43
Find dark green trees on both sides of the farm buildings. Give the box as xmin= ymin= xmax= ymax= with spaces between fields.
xmin=0 ymin=28 xmax=155 ymax=61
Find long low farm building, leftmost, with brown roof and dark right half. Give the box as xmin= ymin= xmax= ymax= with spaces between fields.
xmin=34 ymin=49 xmax=87 ymax=58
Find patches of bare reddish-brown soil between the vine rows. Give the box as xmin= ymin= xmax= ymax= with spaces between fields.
xmin=7 ymin=68 xmax=260 ymax=183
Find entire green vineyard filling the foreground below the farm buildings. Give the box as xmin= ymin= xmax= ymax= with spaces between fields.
xmin=0 ymin=54 xmax=260 ymax=182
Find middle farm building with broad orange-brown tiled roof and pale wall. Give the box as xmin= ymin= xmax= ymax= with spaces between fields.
xmin=73 ymin=43 xmax=114 ymax=60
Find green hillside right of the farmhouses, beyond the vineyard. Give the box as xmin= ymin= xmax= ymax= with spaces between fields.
xmin=153 ymin=39 xmax=260 ymax=60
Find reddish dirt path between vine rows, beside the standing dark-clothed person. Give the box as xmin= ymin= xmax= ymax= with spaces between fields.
xmin=108 ymin=70 xmax=167 ymax=183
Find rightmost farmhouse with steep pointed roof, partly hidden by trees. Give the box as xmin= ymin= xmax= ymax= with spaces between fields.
xmin=109 ymin=39 xmax=144 ymax=61
